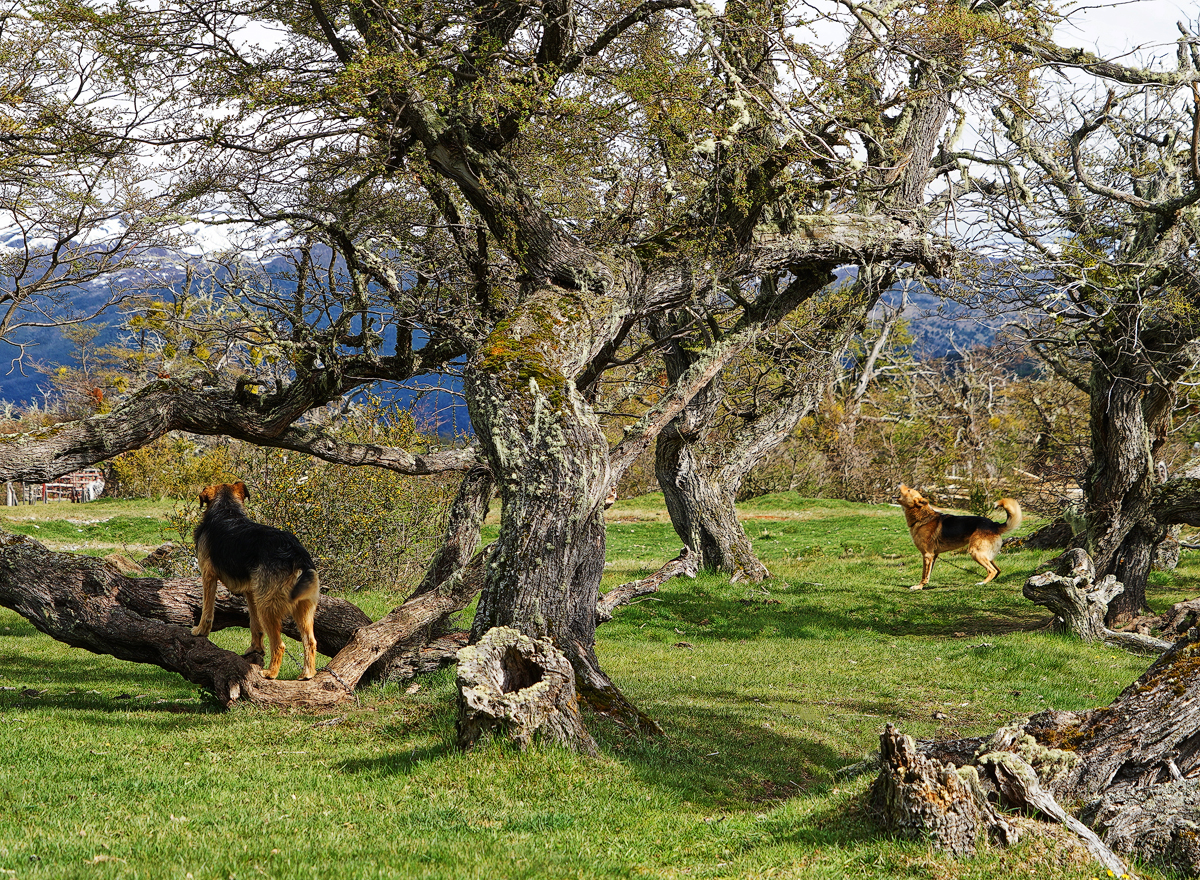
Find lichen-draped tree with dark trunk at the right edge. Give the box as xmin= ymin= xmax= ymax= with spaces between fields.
xmin=960 ymin=34 xmax=1200 ymax=621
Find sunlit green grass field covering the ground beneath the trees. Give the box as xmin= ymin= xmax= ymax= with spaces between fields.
xmin=0 ymin=496 xmax=1185 ymax=880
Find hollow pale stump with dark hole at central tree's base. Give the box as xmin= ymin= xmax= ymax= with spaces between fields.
xmin=458 ymin=627 xmax=599 ymax=755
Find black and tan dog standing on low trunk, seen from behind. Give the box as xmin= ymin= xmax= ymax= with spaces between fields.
xmin=192 ymin=480 xmax=320 ymax=680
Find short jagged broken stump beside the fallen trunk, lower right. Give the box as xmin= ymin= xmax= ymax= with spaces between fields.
xmin=870 ymin=724 xmax=1016 ymax=856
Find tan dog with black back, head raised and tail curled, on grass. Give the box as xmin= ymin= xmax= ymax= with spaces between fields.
xmin=900 ymin=483 xmax=1021 ymax=589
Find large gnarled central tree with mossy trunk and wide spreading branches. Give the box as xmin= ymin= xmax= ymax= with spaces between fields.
xmin=0 ymin=0 xmax=1060 ymax=739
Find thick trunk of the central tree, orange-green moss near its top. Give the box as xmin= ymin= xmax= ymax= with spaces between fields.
xmin=464 ymin=289 xmax=656 ymax=730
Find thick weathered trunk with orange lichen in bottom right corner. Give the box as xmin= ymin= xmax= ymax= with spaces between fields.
xmin=883 ymin=629 xmax=1200 ymax=876
